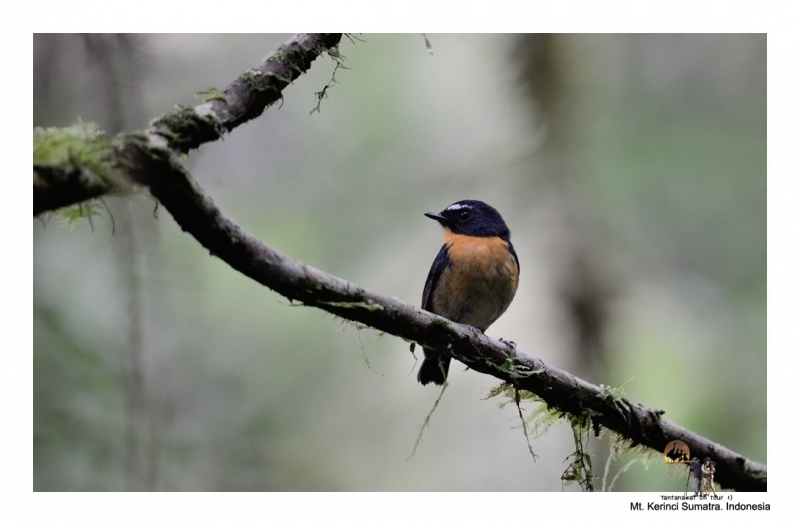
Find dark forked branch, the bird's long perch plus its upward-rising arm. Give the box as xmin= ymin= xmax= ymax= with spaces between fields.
xmin=34 ymin=35 xmax=767 ymax=491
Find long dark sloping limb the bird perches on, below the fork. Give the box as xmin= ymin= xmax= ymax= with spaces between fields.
xmin=115 ymin=134 xmax=767 ymax=491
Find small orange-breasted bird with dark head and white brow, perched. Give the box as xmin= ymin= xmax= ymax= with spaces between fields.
xmin=412 ymin=200 xmax=519 ymax=385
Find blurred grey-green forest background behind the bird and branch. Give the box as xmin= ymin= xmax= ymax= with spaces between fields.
xmin=33 ymin=34 xmax=767 ymax=491
